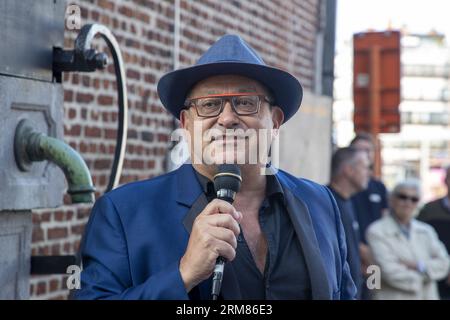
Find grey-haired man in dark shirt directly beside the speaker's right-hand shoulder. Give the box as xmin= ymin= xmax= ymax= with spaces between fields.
xmin=329 ymin=148 xmax=370 ymax=299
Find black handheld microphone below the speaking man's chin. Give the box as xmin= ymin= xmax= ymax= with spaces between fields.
xmin=211 ymin=164 xmax=242 ymax=300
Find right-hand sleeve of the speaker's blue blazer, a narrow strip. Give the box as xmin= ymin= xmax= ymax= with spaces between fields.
xmin=326 ymin=188 xmax=356 ymax=300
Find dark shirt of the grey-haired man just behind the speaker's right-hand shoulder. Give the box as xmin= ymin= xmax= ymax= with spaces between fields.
xmin=329 ymin=186 xmax=363 ymax=299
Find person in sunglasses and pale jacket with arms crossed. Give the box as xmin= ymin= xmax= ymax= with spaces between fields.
xmin=366 ymin=181 xmax=449 ymax=300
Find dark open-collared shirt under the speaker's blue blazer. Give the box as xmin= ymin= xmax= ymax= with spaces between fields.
xmin=197 ymin=173 xmax=311 ymax=300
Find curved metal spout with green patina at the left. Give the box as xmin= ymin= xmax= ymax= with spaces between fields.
xmin=14 ymin=120 xmax=95 ymax=203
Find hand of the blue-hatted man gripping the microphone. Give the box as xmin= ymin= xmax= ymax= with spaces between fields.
xmin=180 ymin=199 xmax=242 ymax=292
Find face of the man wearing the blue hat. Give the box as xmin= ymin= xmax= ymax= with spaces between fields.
xmin=180 ymin=75 xmax=284 ymax=164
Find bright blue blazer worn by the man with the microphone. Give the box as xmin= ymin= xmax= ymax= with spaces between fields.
xmin=73 ymin=164 xmax=356 ymax=300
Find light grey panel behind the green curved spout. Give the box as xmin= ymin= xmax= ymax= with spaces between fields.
xmin=0 ymin=75 xmax=65 ymax=211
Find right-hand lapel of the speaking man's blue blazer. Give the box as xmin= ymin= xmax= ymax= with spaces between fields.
xmin=281 ymin=184 xmax=332 ymax=300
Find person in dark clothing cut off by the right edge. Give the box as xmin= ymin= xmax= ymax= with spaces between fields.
xmin=417 ymin=167 xmax=450 ymax=300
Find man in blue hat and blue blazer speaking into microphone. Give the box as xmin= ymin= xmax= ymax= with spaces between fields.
xmin=75 ymin=35 xmax=355 ymax=300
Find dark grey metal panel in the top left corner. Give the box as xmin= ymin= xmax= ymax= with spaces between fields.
xmin=0 ymin=0 xmax=66 ymax=81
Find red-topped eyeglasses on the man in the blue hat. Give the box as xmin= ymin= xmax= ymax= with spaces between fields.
xmin=184 ymin=93 xmax=273 ymax=118
